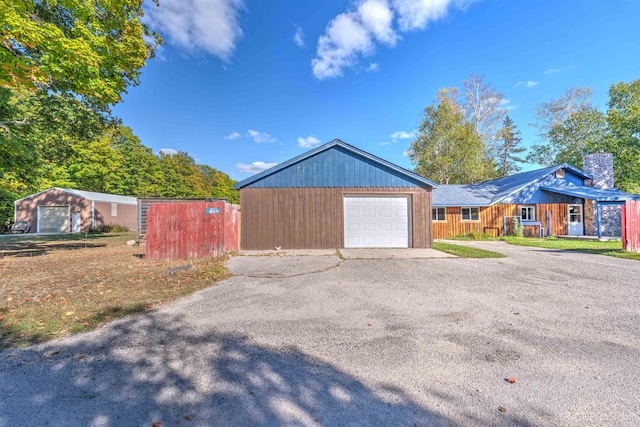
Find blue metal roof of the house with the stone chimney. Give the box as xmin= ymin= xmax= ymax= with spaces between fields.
xmin=433 ymin=163 xmax=591 ymax=206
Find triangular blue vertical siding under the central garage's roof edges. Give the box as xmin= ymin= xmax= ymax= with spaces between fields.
xmin=247 ymin=146 xmax=425 ymax=188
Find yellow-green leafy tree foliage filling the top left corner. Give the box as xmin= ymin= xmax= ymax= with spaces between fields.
xmin=0 ymin=0 xmax=161 ymax=107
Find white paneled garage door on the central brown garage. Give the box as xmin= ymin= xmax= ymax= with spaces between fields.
xmin=344 ymin=196 xmax=409 ymax=248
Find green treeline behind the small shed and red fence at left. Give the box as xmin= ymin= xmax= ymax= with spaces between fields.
xmin=0 ymin=88 xmax=239 ymax=221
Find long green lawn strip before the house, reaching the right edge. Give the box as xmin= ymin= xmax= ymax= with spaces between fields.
xmin=502 ymin=237 xmax=640 ymax=260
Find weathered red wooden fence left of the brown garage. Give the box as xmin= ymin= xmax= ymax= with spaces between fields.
xmin=145 ymin=201 xmax=239 ymax=260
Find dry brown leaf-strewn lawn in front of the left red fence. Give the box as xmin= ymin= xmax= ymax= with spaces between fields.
xmin=0 ymin=233 xmax=228 ymax=350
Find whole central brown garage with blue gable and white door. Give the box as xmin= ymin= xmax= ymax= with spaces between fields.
xmin=235 ymin=140 xmax=435 ymax=250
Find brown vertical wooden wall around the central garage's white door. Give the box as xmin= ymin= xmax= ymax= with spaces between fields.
xmin=240 ymin=187 xmax=432 ymax=250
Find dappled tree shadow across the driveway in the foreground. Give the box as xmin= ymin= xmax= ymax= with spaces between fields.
xmin=0 ymin=313 xmax=460 ymax=427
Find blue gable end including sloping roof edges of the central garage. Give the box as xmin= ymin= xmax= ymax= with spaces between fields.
xmin=234 ymin=139 xmax=437 ymax=189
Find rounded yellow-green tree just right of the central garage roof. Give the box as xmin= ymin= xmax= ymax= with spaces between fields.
xmin=408 ymin=88 xmax=495 ymax=184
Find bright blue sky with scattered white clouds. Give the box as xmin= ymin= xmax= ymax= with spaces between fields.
xmin=114 ymin=0 xmax=640 ymax=180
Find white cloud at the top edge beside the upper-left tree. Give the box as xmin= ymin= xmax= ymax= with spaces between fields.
xmin=145 ymin=0 xmax=244 ymax=61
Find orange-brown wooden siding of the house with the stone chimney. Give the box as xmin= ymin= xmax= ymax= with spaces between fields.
xmin=429 ymin=203 xmax=568 ymax=239
